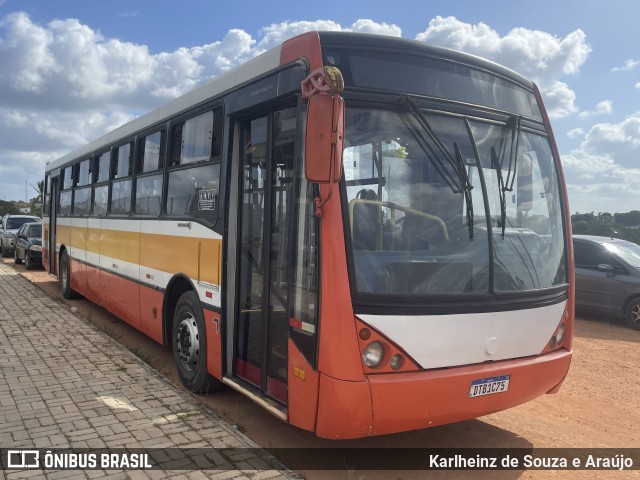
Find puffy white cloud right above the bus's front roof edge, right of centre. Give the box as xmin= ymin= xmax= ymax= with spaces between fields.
xmin=416 ymin=16 xmax=591 ymax=118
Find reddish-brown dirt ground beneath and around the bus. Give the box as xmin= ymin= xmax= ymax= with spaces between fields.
xmin=3 ymin=259 xmax=640 ymax=480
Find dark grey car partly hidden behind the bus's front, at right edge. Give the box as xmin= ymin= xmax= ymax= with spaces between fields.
xmin=573 ymin=235 xmax=640 ymax=330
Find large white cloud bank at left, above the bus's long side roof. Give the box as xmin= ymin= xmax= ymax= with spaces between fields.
xmin=0 ymin=13 xmax=401 ymax=198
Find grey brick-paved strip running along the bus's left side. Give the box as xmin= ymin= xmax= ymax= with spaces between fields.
xmin=0 ymin=262 xmax=295 ymax=479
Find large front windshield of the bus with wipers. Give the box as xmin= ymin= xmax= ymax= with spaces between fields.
xmin=344 ymin=107 xmax=567 ymax=297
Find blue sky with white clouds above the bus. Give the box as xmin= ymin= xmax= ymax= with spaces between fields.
xmin=0 ymin=0 xmax=640 ymax=213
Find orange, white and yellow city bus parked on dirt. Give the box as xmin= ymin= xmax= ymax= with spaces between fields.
xmin=43 ymin=32 xmax=574 ymax=439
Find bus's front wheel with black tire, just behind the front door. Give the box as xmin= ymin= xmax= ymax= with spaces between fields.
xmin=171 ymin=291 xmax=222 ymax=393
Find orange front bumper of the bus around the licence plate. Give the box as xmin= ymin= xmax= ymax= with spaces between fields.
xmin=316 ymin=350 xmax=571 ymax=439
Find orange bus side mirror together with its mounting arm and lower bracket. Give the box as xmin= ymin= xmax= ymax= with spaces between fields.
xmin=301 ymin=67 xmax=344 ymax=217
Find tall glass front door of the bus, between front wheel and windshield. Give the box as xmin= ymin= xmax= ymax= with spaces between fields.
xmin=234 ymin=108 xmax=296 ymax=404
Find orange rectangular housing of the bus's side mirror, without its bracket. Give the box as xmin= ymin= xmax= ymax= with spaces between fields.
xmin=304 ymin=94 xmax=344 ymax=183
